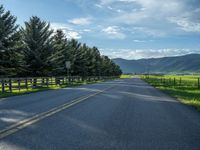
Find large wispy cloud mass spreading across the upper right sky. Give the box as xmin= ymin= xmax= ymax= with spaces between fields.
xmin=97 ymin=0 xmax=200 ymax=37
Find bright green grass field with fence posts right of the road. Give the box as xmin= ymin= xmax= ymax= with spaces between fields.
xmin=142 ymin=75 xmax=200 ymax=111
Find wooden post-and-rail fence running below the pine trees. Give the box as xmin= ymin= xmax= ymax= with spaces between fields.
xmin=0 ymin=76 xmax=116 ymax=93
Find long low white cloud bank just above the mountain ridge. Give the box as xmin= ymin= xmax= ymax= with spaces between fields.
xmin=100 ymin=49 xmax=200 ymax=60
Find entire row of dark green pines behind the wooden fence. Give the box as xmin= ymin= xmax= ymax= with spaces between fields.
xmin=0 ymin=5 xmax=122 ymax=77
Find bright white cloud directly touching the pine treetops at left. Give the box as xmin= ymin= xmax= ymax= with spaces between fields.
xmin=51 ymin=23 xmax=82 ymax=39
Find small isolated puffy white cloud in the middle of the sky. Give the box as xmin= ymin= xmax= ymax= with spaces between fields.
xmin=102 ymin=26 xmax=126 ymax=39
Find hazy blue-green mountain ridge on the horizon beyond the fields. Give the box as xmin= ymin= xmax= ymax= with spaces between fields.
xmin=113 ymin=54 xmax=200 ymax=73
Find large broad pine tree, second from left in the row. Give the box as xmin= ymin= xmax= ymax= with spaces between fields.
xmin=21 ymin=16 xmax=53 ymax=76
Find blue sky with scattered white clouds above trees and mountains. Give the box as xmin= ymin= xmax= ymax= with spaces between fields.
xmin=0 ymin=0 xmax=200 ymax=59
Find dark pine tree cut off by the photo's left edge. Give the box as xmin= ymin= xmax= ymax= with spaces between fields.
xmin=0 ymin=5 xmax=20 ymax=76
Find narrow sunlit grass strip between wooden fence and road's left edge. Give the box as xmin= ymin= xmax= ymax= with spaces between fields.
xmin=0 ymin=80 xmax=106 ymax=100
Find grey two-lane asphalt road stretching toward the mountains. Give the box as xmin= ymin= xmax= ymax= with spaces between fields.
xmin=0 ymin=78 xmax=200 ymax=150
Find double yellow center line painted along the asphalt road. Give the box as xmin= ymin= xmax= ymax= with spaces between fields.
xmin=0 ymin=86 xmax=113 ymax=139
